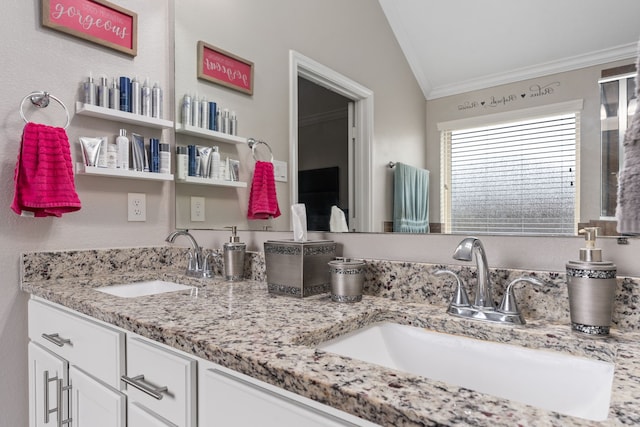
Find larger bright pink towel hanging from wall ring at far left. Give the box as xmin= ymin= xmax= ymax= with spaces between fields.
xmin=11 ymin=123 xmax=80 ymax=217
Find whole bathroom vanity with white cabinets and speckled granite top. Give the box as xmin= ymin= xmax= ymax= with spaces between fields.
xmin=22 ymin=248 xmax=640 ymax=426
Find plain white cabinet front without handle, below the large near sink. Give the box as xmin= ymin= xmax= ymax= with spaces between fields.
xmin=198 ymin=367 xmax=373 ymax=427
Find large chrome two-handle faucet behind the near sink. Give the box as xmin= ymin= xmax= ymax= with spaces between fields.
xmin=435 ymin=237 xmax=544 ymax=325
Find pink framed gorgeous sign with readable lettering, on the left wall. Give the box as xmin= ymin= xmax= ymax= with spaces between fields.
xmin=41 ymin=0 xmax=138 ymax=56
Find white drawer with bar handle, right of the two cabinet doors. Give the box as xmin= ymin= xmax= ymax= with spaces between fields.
xmin=127 ymin=337 xmax=197 ymax=427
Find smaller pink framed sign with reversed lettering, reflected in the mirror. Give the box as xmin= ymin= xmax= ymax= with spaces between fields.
xmin=198 ymin=40 xmax=253 ymax=95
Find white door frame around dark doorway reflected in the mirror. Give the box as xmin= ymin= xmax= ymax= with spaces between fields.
xmin=289 ymin=51 xmax=373 ymax=232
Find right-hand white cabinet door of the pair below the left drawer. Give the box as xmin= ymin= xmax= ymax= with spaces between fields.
xmin=69 ymin=365 xmax=127 ymax=427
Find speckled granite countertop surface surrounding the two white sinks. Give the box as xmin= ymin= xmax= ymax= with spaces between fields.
xmin=22 ymin=269 xmax=640 ymax=427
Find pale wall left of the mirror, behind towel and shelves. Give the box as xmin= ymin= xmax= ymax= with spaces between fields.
xmin=0 ymin=0 xmax=174 ymax=427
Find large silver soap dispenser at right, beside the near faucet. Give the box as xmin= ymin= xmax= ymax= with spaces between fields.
xmin=566 ymin=227 xmax=616 ymax=336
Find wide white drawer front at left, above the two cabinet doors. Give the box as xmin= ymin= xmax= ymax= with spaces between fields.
xmin=29 ymin=300 xmax=125 ymax=389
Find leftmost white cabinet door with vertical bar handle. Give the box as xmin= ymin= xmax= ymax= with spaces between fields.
xmin=29 ymin=342 xmax=69 ymax=427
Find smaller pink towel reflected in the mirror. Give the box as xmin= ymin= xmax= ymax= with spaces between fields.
xmin=247 ymin=161 xmax=280 ymax=219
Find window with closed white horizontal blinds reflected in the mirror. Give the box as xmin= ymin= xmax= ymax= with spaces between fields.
xmin=441 ymin=108 xmax=580 ymax=235
